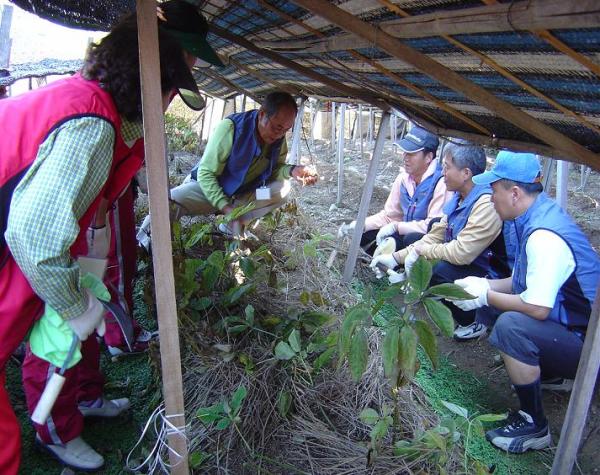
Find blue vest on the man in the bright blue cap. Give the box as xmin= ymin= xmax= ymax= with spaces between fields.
xmin=512 ymin=193 xmax=600 ymax=333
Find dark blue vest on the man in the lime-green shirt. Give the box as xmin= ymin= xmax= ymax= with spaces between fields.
xmin=191 ymin=110 xmax=285 ymax=196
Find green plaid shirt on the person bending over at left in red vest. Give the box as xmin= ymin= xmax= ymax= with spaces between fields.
xmin=5 ymin=117 xmax=142 ymax=320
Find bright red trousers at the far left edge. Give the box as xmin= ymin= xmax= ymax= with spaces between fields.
xmin=0 ymin=248 xmax=44 ymax=475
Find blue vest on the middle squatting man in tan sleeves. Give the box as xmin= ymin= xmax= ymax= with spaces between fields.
xmin=444 ymin=185 xmax=492 ymax=273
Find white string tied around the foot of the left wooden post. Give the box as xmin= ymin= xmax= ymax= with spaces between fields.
xmin=125 ymin=403 xmax=188 ymax=474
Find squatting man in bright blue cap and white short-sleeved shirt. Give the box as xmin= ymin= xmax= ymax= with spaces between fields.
xmin=456 ymin=151 xmax=600 ymax=453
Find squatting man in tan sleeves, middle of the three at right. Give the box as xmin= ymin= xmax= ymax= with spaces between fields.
xmin=371 ymin=142 xmax=507 ymax=340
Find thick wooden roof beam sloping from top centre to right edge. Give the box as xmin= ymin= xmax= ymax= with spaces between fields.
xmin=293 ymin=0 xmax=600 ymax=166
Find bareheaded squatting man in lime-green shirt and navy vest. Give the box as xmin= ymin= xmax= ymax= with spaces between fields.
xmin=138 ymin=91 xmax=317 ymax=244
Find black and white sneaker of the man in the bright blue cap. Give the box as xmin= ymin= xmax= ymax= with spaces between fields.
xmin=485 ymin=411 xmax=552 ymax=454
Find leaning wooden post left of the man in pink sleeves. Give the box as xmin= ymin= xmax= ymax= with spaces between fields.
xmin=342 ymin=112 xmax=390 ymax=282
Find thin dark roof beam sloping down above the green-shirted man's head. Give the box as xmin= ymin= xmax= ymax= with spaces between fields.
xmin=209 ymin=25 xmax=389 ymax=109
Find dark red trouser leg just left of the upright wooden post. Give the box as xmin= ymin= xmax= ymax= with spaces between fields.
xmin=104 ymin=185 xmax=141 ymax=348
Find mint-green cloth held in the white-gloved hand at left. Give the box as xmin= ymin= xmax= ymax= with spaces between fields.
xmin=29 ymin=272 xmax=110 ymax=369
